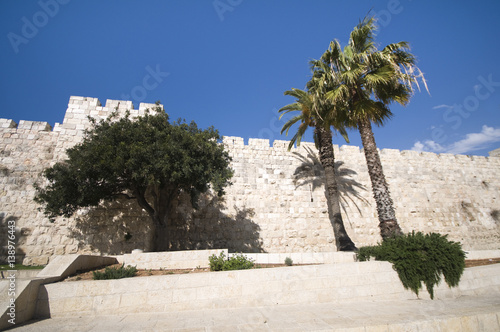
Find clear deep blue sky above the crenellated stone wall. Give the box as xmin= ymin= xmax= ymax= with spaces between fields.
xmin=0 ymin=0 xmax=500 ymax=155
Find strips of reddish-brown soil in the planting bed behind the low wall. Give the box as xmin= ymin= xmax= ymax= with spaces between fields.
xmin=64 ymin=258 xmax=500 ymax=281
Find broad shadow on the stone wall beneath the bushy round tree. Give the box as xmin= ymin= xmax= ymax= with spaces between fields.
xmin=68 ymin=189 xmax=263 ymax=255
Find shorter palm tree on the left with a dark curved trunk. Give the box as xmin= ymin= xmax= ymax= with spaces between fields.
xmin=278 ymin=79 xmax=356 ymax=251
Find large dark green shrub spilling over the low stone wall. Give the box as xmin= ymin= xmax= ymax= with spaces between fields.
xmin=356 ymin=232 xmax=465 ymax=299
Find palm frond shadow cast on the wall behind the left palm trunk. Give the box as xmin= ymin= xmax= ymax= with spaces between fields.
xmin=293 ymin=147 xmax=370 ymax=218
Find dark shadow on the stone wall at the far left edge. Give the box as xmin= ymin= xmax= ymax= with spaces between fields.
xmin=0 ymin=212 xmax=28 ymax=264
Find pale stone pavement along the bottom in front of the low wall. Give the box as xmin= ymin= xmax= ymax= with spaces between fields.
xmin=9 ymin=293 xmax=500 ymax=332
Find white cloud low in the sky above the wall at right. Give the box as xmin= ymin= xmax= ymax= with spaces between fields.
xmin=411 ymin=125 xmax=500 ymax=154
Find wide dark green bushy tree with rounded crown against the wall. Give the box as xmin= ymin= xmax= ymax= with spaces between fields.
xmin=35 ymin=107 xmax=233 ymax=250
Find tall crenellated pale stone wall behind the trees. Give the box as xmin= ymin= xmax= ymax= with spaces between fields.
xmin=0 ymin=97 xmax=500 ymax=264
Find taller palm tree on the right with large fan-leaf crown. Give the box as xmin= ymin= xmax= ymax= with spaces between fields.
xmin=313 ymin=17 xmax=427 ymax=239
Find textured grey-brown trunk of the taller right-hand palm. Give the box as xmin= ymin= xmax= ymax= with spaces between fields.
xmin=358 ymin=119 xmax=403 ymax=239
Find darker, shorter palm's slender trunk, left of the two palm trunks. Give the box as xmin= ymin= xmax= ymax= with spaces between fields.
xmin=315 ymin=126 xmax=356 ymax=251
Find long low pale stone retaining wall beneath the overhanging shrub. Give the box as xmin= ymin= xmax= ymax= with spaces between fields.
xmin=36 ymin=262 xmax=500 ymax=317
